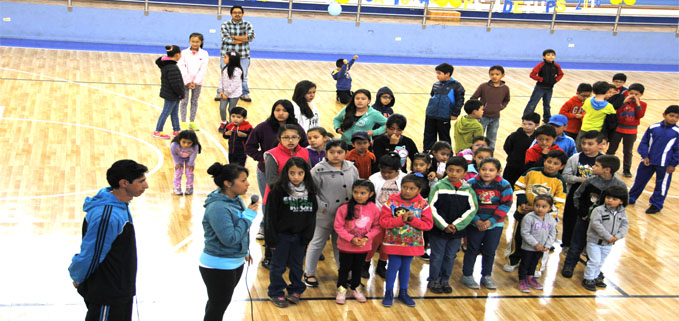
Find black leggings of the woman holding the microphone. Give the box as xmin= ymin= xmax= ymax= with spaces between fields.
xmin=199 ymin=264 xmax=245 ymax=321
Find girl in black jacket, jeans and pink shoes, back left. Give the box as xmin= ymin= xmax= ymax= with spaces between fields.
xmin=153 ymin=45 xmax=184 ymax=139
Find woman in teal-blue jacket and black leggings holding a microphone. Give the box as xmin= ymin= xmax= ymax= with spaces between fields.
xmin=200 ymin=163 xmax=259 ymax=321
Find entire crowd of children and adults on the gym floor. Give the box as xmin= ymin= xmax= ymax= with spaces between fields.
xmin=69 ymin=7 xmax=679 ymax=320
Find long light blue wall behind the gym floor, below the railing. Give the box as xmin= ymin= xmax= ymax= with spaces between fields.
xmin=0 ymin=2 xmax=679 ymax=69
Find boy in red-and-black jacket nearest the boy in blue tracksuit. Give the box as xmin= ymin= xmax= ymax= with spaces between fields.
xmin=606 ymin=83 xmax=646 ymax=177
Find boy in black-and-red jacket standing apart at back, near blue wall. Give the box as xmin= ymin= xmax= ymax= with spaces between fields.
xmin=523 ymin=49 xmax=563 ymax=123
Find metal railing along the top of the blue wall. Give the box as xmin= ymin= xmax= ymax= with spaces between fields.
xmin=66 ymin=0 xmax=679 ymax=37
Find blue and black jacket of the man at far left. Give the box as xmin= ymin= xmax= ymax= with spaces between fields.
xmin=68 ymin=187 xmax=137 ymax=305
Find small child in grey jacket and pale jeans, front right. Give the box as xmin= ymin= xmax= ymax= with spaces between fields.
xmin=582 ymin=186 xmax=629 ymax=291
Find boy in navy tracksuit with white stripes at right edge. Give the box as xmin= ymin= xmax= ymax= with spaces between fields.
xmin=629 ymin=105 xmax=679 ymax=214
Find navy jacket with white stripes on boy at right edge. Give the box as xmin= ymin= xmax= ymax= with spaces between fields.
xmin=637 ymin=121 xmax=679 ymax=166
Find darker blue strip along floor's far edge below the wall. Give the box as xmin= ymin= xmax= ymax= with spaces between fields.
xmin=0 ymin=38 xmax=679 ymax=72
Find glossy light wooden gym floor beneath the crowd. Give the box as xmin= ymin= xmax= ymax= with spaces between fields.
xmin=0 ymin=47 xmax=679 ymax=320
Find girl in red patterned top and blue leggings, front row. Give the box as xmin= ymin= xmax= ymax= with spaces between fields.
xmin=380 ymin=174 xmax=434 ymax=307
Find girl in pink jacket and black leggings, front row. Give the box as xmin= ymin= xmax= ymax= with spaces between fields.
xmin=335 ymin=179 xmax=381 ymax=304
